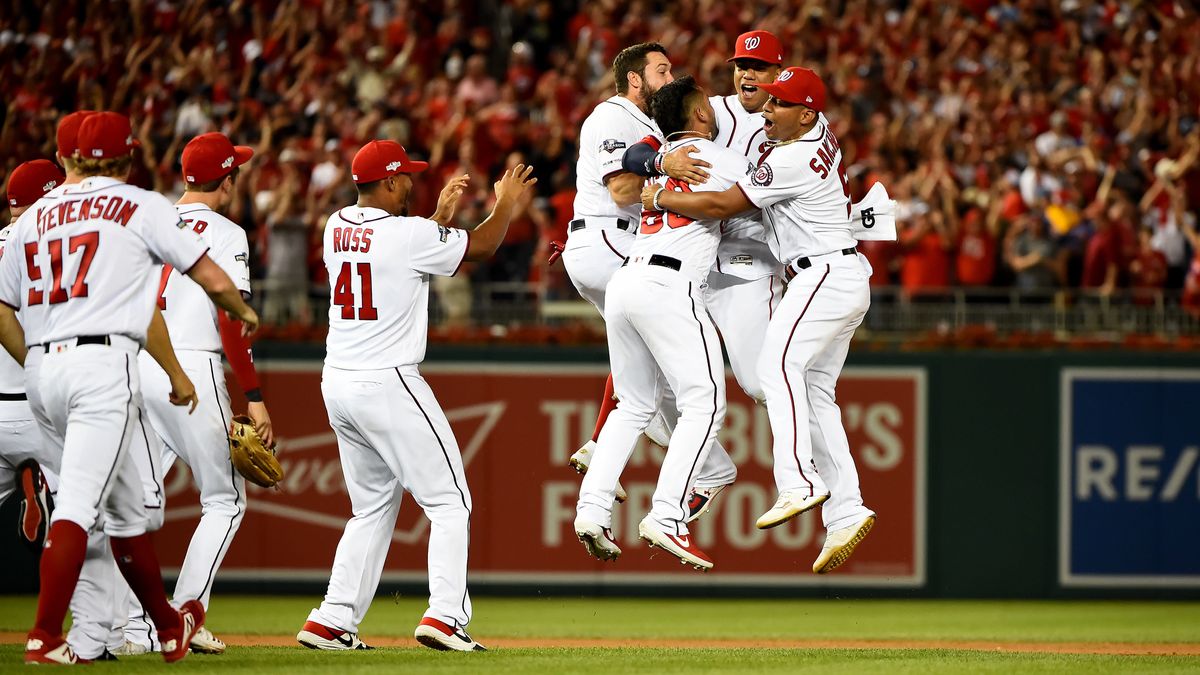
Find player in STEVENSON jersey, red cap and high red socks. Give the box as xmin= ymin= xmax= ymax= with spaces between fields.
xmin=0 ymin=113 xmax=257 ymax=663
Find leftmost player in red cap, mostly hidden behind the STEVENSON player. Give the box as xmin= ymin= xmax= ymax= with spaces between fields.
xmin=0 ymin=160 xmax=66 ymax=549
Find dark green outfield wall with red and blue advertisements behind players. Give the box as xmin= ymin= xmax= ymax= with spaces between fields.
xmin=0 ymin=346 xmax=1200 ymax=597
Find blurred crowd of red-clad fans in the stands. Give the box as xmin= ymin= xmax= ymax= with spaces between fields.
xmin=0 ymin=0 xmax=1200 ymax=323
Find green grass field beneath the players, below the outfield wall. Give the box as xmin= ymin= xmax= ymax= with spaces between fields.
xmin=0 ymin=596 xmax=1200 ymax=674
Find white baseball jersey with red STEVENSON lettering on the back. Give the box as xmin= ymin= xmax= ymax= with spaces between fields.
xmin=0 ymin=177 xmax=206 ymax=344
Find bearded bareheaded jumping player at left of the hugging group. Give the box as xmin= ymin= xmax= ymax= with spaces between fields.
xmin=563 ymin=42 xmax=674 ymax=501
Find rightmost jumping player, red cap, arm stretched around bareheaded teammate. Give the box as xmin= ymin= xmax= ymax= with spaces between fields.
xmin=642 ymin=67 xmax=875 ymax=573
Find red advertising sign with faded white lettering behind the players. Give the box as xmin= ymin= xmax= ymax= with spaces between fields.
xmin=157 ymin=362 xmax=925 ymax=587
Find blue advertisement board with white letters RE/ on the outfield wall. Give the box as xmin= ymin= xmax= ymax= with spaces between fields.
xmin=1058 ymin=368 xmax=1200 ymax=587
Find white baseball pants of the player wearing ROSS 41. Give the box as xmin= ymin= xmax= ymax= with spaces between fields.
xmin=308 ymin=365 xmax=472 ymax=632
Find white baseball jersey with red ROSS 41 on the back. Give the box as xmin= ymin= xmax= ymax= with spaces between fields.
xmin=324 ymin=207 xmax=470 ymax=370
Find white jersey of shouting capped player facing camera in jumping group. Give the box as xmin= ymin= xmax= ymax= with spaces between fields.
xmin=708 ymin=96 xmax=779 ymax=280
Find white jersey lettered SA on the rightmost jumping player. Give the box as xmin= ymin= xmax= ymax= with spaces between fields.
xmin=738 ymin=114 xmax=857 ymax=263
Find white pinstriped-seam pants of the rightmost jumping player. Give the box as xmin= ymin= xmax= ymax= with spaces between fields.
xmin=758 ymin=252 xmax=871 ymax=530
